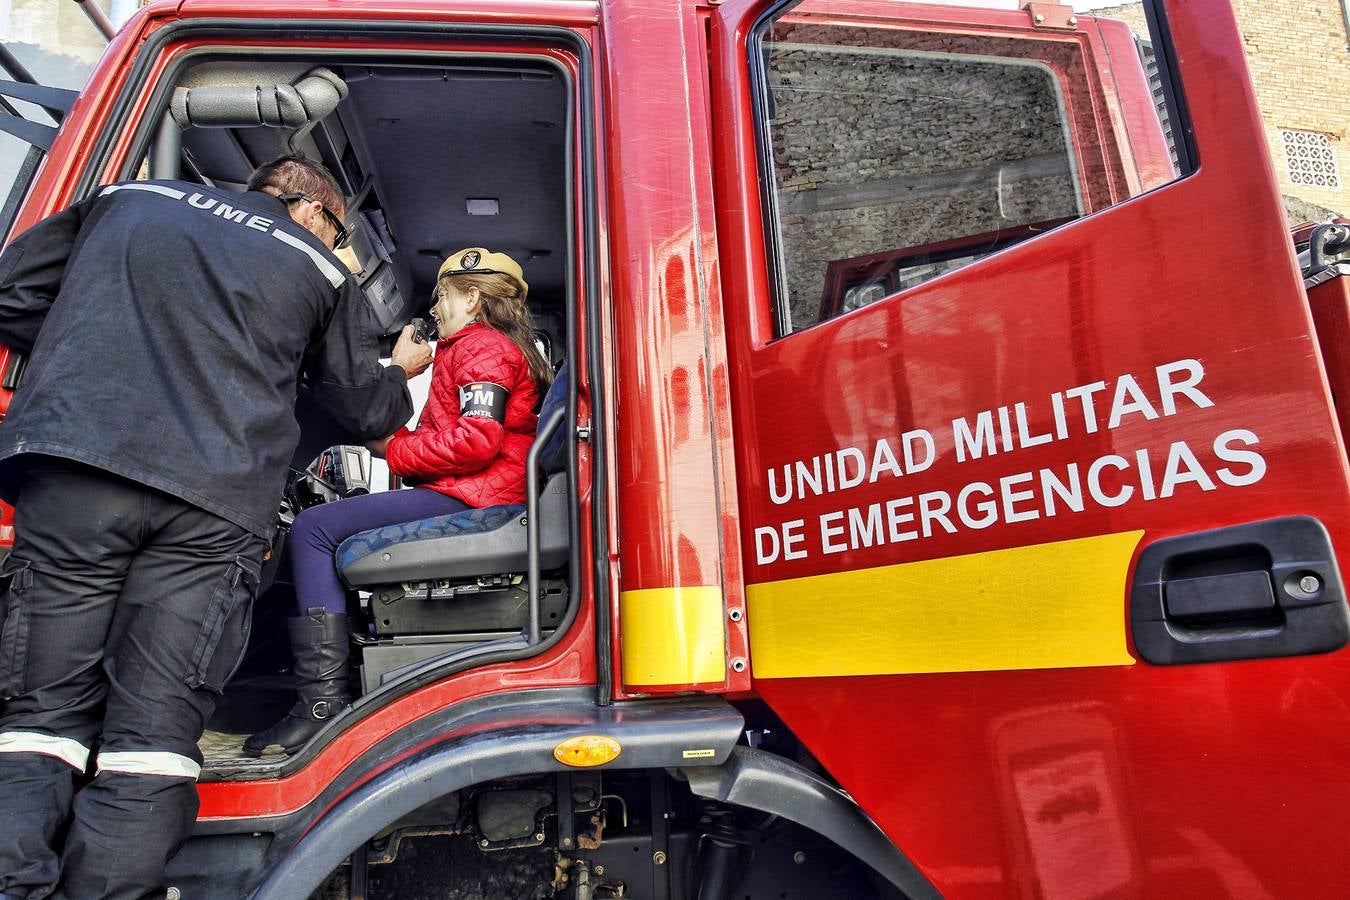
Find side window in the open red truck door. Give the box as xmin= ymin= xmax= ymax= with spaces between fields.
xmin=751 ymin=0 xmax=1187 ymax=336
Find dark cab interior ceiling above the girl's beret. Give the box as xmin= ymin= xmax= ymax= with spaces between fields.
xmin=177 ymin=59 xmax=568 ymax=323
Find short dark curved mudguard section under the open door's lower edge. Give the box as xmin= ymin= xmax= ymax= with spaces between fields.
xmin=683 ymin=746 xmax=942 ymax=900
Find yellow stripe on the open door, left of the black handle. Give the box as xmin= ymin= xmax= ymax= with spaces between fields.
xmin=747 ymin=532 xmax=1143 ymax=679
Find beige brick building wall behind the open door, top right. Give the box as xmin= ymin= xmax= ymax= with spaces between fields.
xmin=1094 ymin=0 xmax=1350 ymax=221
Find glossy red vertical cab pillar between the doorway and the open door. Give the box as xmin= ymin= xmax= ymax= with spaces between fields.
xmin=602 ymin=0 xmax=748 ymax=692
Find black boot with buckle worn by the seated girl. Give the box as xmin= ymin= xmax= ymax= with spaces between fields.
xmin=244 ymin=606 xmax=351 ymax=757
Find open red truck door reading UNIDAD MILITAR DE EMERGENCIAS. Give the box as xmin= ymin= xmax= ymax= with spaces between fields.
xmin=710 ymin=0 xmax=1350 ymax=897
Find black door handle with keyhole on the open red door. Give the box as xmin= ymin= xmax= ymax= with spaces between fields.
xmin=1130 ymin=515 xmax=1350 ymax=665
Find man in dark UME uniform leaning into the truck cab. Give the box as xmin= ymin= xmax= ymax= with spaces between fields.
xmin=0 ymin=158 xmax=431 ymax=900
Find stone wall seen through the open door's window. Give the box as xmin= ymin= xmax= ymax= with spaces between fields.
xmin=770 ymin=28 xmax=1077 ymax=328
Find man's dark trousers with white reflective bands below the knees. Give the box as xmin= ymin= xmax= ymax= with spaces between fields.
xmin=0 ymin=457 xmax=265 ymax=900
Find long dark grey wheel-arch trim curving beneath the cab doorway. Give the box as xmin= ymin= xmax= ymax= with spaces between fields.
xmin=250 ymin=692 xmax=745 ymax=900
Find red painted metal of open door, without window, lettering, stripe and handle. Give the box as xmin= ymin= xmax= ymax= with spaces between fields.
xmin=713 ymin=0 xmax=1350 ymax=897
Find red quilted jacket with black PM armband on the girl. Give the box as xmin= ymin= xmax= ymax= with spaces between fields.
xmin=385 ymin=324 xmax=539 ymax=507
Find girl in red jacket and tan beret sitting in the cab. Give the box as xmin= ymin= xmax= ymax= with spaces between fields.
xmin=244 ymin=247 xmax=554 ymax=756
